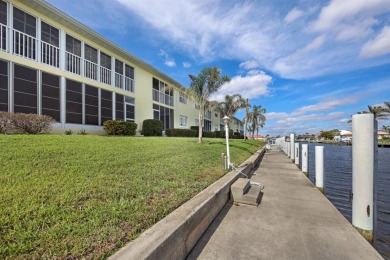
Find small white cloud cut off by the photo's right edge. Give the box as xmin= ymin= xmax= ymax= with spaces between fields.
xmin=360 ymin=26 xmax=390 ymax=58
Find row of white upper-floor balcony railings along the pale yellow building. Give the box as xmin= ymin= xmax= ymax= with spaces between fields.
xmin=0 ymin=24 xmax=134 ymax=93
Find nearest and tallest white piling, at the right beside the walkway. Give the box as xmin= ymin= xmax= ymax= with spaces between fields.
xmin=352 ymin=114 xmax=377 ymax=242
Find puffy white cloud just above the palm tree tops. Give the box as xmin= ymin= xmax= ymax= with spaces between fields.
xmin=210 ymin=71 xmax=272 ymax=101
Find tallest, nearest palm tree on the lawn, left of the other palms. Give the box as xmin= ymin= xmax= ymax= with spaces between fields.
xmin=183 ymin=67 xmax=230 ymax=143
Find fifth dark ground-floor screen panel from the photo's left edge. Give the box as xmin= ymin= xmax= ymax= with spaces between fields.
xmin=84 ymin=85 xmax=99 ymax=125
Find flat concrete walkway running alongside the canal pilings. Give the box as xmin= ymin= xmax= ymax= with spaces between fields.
xmin=188 ymin=148 xmax=383 ymax=260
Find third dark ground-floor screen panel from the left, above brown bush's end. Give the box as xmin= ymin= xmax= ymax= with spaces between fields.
xmin=42 ymin=72 xmax=61 ymax=122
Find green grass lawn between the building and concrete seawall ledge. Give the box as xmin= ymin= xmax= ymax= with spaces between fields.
xmin=0 ymin=135 xmax=262 ymax=259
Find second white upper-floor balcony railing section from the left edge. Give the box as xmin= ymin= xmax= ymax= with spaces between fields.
xmin=12 ymin=30 xmax=37 ymax=60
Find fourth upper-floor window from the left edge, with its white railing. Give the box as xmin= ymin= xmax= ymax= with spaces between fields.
xmin=65 ymin=35 xmax=81 ymax=75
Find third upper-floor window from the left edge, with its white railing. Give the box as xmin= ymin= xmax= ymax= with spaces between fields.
xmin=41 ymin=22 xmax=60 ymax=67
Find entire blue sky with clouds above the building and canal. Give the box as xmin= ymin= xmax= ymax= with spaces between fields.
xmin=48 ymin=0 xmax=390 ymax=135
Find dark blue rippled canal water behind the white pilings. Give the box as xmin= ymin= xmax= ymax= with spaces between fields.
xmin=299 ymin=143 xmax=390 ymax=260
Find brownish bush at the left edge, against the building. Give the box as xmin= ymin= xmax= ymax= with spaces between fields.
xmin=0 ymin=112 xmax=55 ymax=134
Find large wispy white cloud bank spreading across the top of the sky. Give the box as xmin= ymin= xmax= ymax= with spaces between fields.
xmin=116 ymin=0 xmax=390 ymax=79
